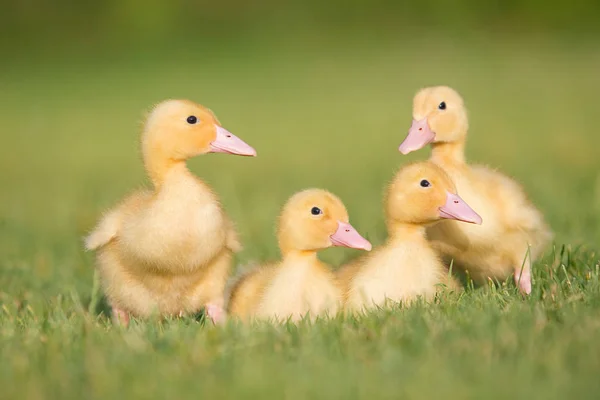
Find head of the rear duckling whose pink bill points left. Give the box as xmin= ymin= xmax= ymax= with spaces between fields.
xmin=398 ymin=86 xmax=469 ymax=154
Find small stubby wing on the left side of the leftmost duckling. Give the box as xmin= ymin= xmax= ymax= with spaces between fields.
xmin=85 ymin=191 xmax=151 ymax=250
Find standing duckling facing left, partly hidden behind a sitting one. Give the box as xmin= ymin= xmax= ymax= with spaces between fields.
xmin=399 ymin=86 xmax=553 ymax=294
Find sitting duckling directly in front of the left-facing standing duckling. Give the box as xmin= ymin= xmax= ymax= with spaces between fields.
xmin=338 ymin=162 xmax=482 ymax=311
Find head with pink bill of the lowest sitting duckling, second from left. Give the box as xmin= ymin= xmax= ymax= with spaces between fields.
xmin=277 ymin=189 xmax=371 ymax=254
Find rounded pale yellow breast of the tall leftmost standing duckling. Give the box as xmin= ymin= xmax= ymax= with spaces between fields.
xmin=120 ymin=173 xmax=227 ymax=272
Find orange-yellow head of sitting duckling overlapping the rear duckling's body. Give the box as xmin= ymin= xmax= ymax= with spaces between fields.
xmin=385 ymin=161 xmax=482 ymax=226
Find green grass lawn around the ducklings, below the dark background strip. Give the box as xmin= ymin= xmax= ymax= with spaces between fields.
xmin=0 ymin=39 xmax=600 ymax=399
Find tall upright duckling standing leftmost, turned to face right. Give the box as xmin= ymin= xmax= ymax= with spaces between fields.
xmin=85 ymin=100 xmax=256 ymax=325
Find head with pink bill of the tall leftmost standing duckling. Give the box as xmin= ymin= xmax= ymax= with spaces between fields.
xmin=142 ymin=100 xmax=256 ymax=161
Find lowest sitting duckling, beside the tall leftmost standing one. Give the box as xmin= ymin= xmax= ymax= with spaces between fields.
xmin=228 ymin=189 xmax=371 ymax=321
